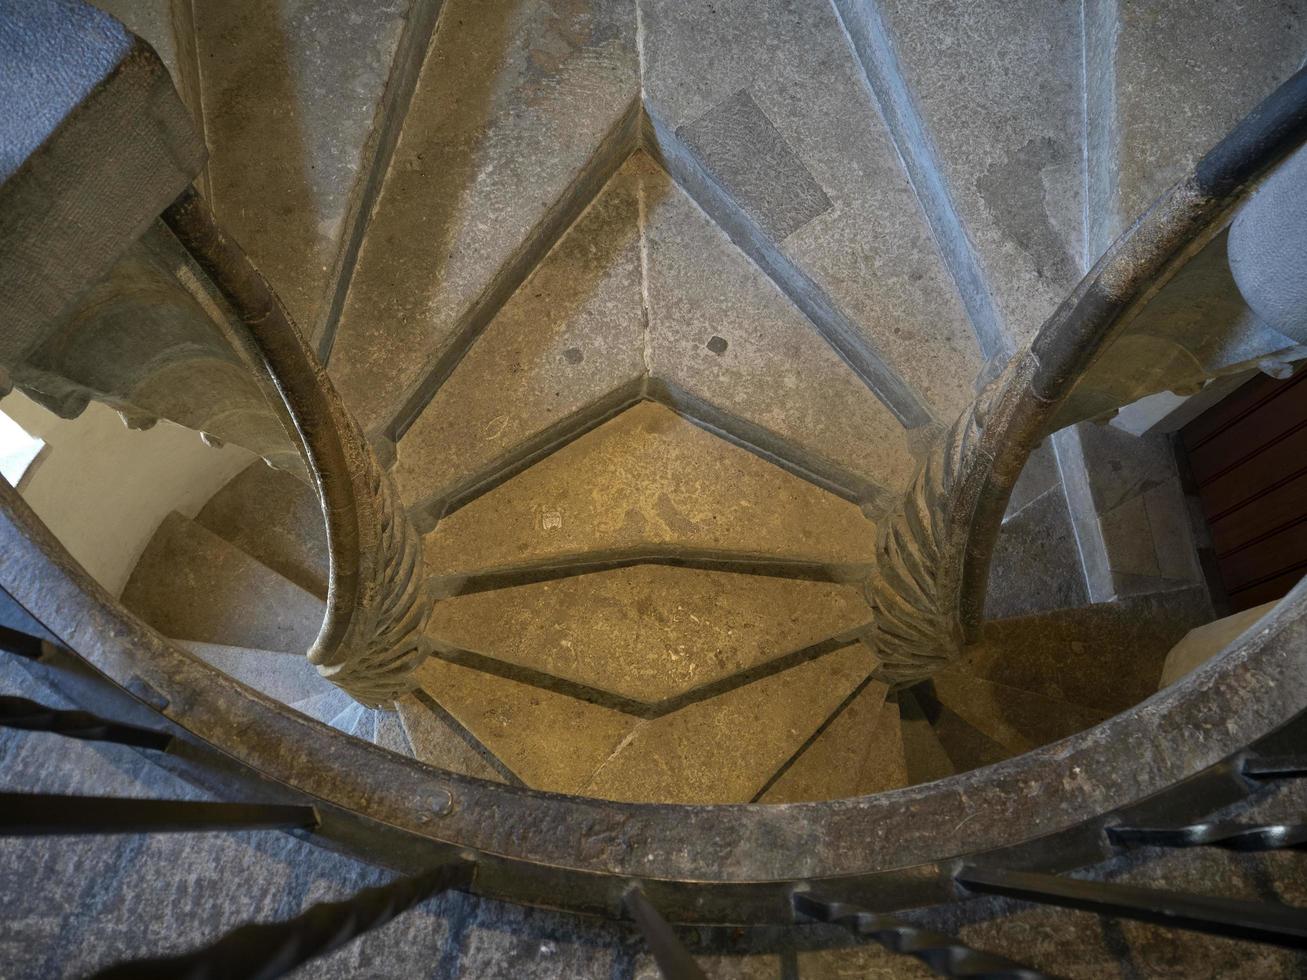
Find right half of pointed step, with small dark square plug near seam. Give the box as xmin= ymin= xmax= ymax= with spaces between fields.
xmin=642 ymin=152 xmax=915 ymax=499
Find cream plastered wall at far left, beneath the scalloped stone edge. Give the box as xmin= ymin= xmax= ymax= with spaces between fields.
xmin=0 ymin=392 xmax=257 ymax=596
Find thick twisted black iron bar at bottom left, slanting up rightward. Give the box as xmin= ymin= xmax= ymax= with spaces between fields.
xmin=93 ymin=860 xmax=476 ymax=980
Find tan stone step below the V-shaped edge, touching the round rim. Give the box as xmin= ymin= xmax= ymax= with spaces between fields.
xmin=401 ymin=644 xmax=874 ymax=802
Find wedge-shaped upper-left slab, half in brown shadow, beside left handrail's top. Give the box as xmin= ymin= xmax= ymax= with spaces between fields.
xmin=193 ymin=0 xmax=413 ymax=333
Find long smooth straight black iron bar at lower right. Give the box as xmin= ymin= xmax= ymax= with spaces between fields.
xmin=954 ymin=868 xmax=1307 ymax=949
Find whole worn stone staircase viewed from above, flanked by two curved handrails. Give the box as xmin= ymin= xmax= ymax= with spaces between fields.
xmin=92 ymin=0 xmax=1302 ymax=802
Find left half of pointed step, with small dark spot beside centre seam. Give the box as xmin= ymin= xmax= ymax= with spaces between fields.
xmin=395 ymin=152 xmax=646 ymax=511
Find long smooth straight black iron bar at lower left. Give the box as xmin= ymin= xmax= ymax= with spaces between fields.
xmin=0 ymin=793 xmax=318 ymax=838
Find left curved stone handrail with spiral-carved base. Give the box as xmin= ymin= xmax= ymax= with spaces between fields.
xmin=163 ymin=189 xmax=431 ymax=707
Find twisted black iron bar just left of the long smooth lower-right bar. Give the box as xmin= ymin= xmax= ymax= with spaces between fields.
xmin=792 ymin=891 xmax=1056 ymax=980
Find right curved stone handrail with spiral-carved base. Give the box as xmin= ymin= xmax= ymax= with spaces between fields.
xmin=867 ymin=68 xmax=1307 ymax=683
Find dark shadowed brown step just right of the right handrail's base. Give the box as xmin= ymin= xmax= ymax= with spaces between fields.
xmin=957 ymin=587 xmax=1214 ymax=715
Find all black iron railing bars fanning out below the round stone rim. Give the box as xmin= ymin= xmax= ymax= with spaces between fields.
xmin=0 ymin=630 xmax=1307 ymax=980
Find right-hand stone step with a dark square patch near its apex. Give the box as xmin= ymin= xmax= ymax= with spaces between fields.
xmin=640 ymin=0 xmax=982 ymax=427
